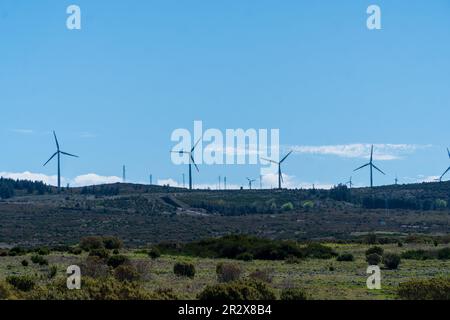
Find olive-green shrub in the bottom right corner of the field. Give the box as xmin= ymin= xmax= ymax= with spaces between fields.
xmin=397 ymin=278 xmax=450 ymax=300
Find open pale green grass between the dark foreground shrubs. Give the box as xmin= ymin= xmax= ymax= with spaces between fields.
xmin=0 ymin=244 xmax=450 ymax=300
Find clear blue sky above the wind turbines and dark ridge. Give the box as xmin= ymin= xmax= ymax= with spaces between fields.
xmin=0 ymin=0 xmax=450 ymax=187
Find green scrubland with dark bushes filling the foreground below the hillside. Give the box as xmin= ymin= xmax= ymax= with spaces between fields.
xmin=0 ymin=235 xmax=450 ymax=300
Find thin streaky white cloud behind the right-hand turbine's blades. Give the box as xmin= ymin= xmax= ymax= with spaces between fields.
xmin=290 ymin=143 xmax=430 ymax=161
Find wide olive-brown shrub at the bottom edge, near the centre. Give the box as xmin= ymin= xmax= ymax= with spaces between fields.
xmin=198 ymin=280 xmax=276 ymax=301
